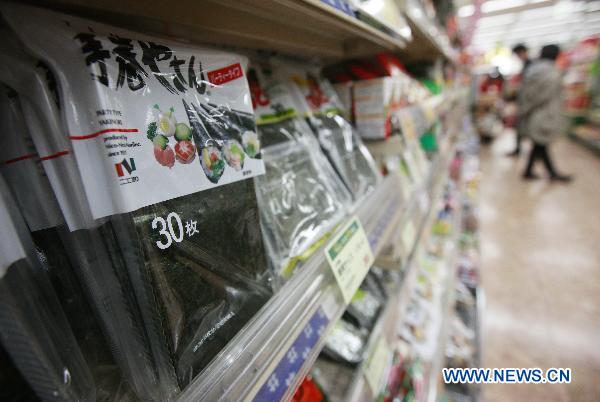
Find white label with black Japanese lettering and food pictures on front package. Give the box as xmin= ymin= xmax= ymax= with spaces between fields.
xmin=2 ymin=4 xmax=264 ymax=219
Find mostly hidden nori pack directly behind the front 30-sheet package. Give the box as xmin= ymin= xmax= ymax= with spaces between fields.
xmin=0 ymin=32 xmax=178 ymax=400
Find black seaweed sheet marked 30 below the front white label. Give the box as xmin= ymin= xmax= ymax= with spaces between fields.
xmin=123 ymin=180 xmax=270 ymax=387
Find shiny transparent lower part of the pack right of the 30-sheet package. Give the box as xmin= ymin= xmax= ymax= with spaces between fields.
xmin=255 ymin=140 xmax=348 ymax=278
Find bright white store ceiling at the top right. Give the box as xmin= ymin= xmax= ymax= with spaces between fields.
xmin=455 ymin=0 xmax=600 ymax=52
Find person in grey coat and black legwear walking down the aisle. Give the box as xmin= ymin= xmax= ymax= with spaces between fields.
xmin=519 ymin=45 xmax=571 ymax=182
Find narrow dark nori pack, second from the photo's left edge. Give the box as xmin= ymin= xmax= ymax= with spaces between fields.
xmin=0 ymin=87 xmax=129 ymax=401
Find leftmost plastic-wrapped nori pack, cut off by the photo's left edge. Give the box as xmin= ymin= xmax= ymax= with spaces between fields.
xmin=0 ymin=180 xmax=96 ymax=401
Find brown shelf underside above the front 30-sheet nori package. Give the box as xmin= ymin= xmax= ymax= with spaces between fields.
xmin=31 ymin=0 xmax=404 ymax=59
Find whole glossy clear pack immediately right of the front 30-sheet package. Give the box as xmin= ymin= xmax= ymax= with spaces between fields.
xmin=248 ymin=63 xmax=351 ymax=279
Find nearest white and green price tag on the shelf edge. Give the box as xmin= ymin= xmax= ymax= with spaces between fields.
xmin=325 ymin=216 xmax=375 ymax=304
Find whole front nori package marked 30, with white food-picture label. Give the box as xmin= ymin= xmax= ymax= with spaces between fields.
xmin=2 ymin=5 xmax=270 ymax=400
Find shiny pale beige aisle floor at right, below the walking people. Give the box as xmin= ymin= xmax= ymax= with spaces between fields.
xmin=480 ymin=135 xmax=600 ymax=402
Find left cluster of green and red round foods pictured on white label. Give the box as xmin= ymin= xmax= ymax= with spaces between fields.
xmin=146 ymin=105 xmax=196 ymax=168
